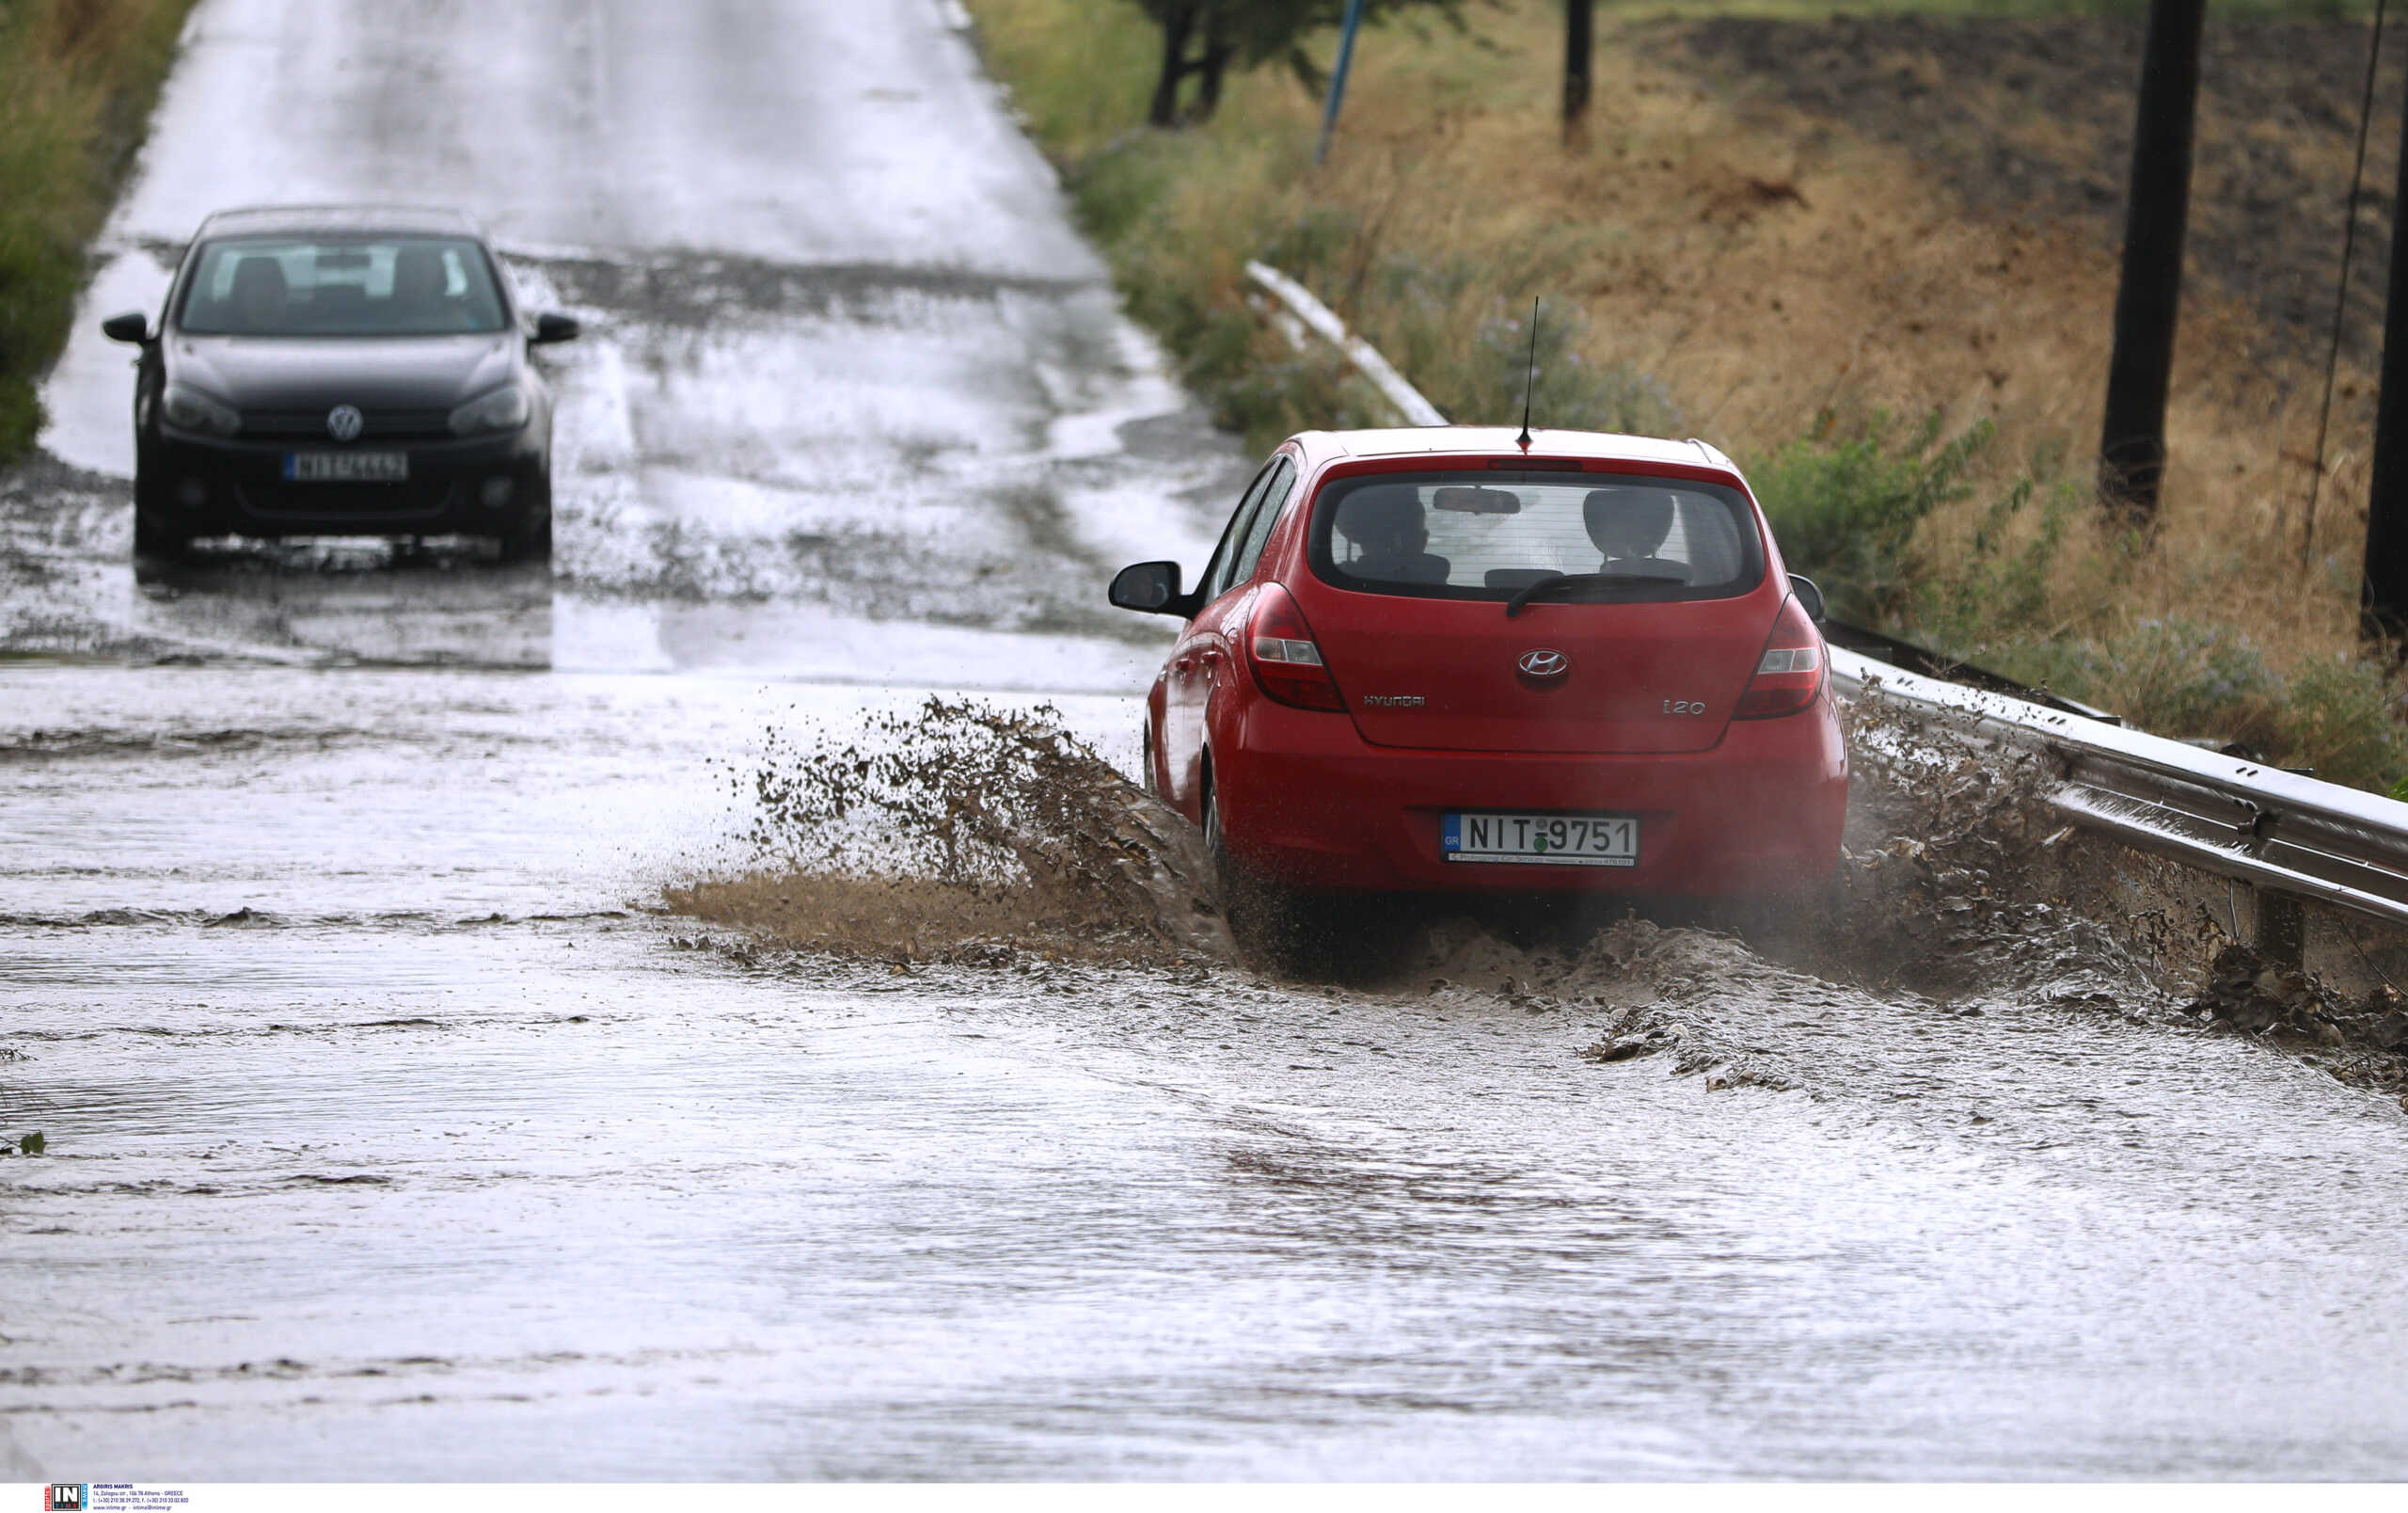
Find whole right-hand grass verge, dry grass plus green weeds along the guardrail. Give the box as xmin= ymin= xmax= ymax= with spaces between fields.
xmin=971 ymin=0 xmax=2408 ymax=788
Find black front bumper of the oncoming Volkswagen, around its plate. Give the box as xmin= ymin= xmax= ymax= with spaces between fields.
xmin=139 ymin=424 xmax=551 ymax=537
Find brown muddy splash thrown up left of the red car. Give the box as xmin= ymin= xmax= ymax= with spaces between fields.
xmin=670 ymin=696 xmax=1228 ymax=962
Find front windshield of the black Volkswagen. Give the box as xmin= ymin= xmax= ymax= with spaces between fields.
xmin=176 ymin=236 xmax=503 ymax=337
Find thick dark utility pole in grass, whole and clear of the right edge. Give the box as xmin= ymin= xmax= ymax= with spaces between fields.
xmin=2099 ymin=0 xmax=2206 ymax=523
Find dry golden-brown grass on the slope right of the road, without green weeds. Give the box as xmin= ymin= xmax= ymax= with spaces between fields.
xmin=973 ymin=0 xmax=2408 ymax=781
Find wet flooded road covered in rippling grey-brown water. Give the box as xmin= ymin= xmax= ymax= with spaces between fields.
xmin=0 ymin=0 xmax=2408 ymax=1482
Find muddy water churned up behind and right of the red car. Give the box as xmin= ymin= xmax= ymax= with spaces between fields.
xmin=1357 ymin=709 xmax=2213 ymax=1099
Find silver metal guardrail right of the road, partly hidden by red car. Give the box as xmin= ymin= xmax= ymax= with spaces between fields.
xmin=1245 ymin=263 xmax=2408 ymax=939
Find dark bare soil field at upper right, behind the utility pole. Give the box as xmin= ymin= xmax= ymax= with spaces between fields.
xmin=1678 ymin=14 xmax=2408 ymax=377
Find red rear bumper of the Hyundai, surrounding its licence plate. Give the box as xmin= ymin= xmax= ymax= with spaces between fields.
xmin=1213 ymin=689 xmax=1847 ymax=897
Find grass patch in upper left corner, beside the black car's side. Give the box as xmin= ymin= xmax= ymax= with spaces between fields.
xmin=0 ymin=0 xmax=193 ymax=460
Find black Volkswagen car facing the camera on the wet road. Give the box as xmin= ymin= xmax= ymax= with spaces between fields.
xmin=102 ymin=207 xmax=578 ymax=562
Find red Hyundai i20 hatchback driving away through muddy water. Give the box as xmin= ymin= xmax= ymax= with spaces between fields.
xmin=1110 ymin=426 xmax=1847 ymax=920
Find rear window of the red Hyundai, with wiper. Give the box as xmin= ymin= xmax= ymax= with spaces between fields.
xmin=1312 ymin=472 xmax=1765 ymax=602
